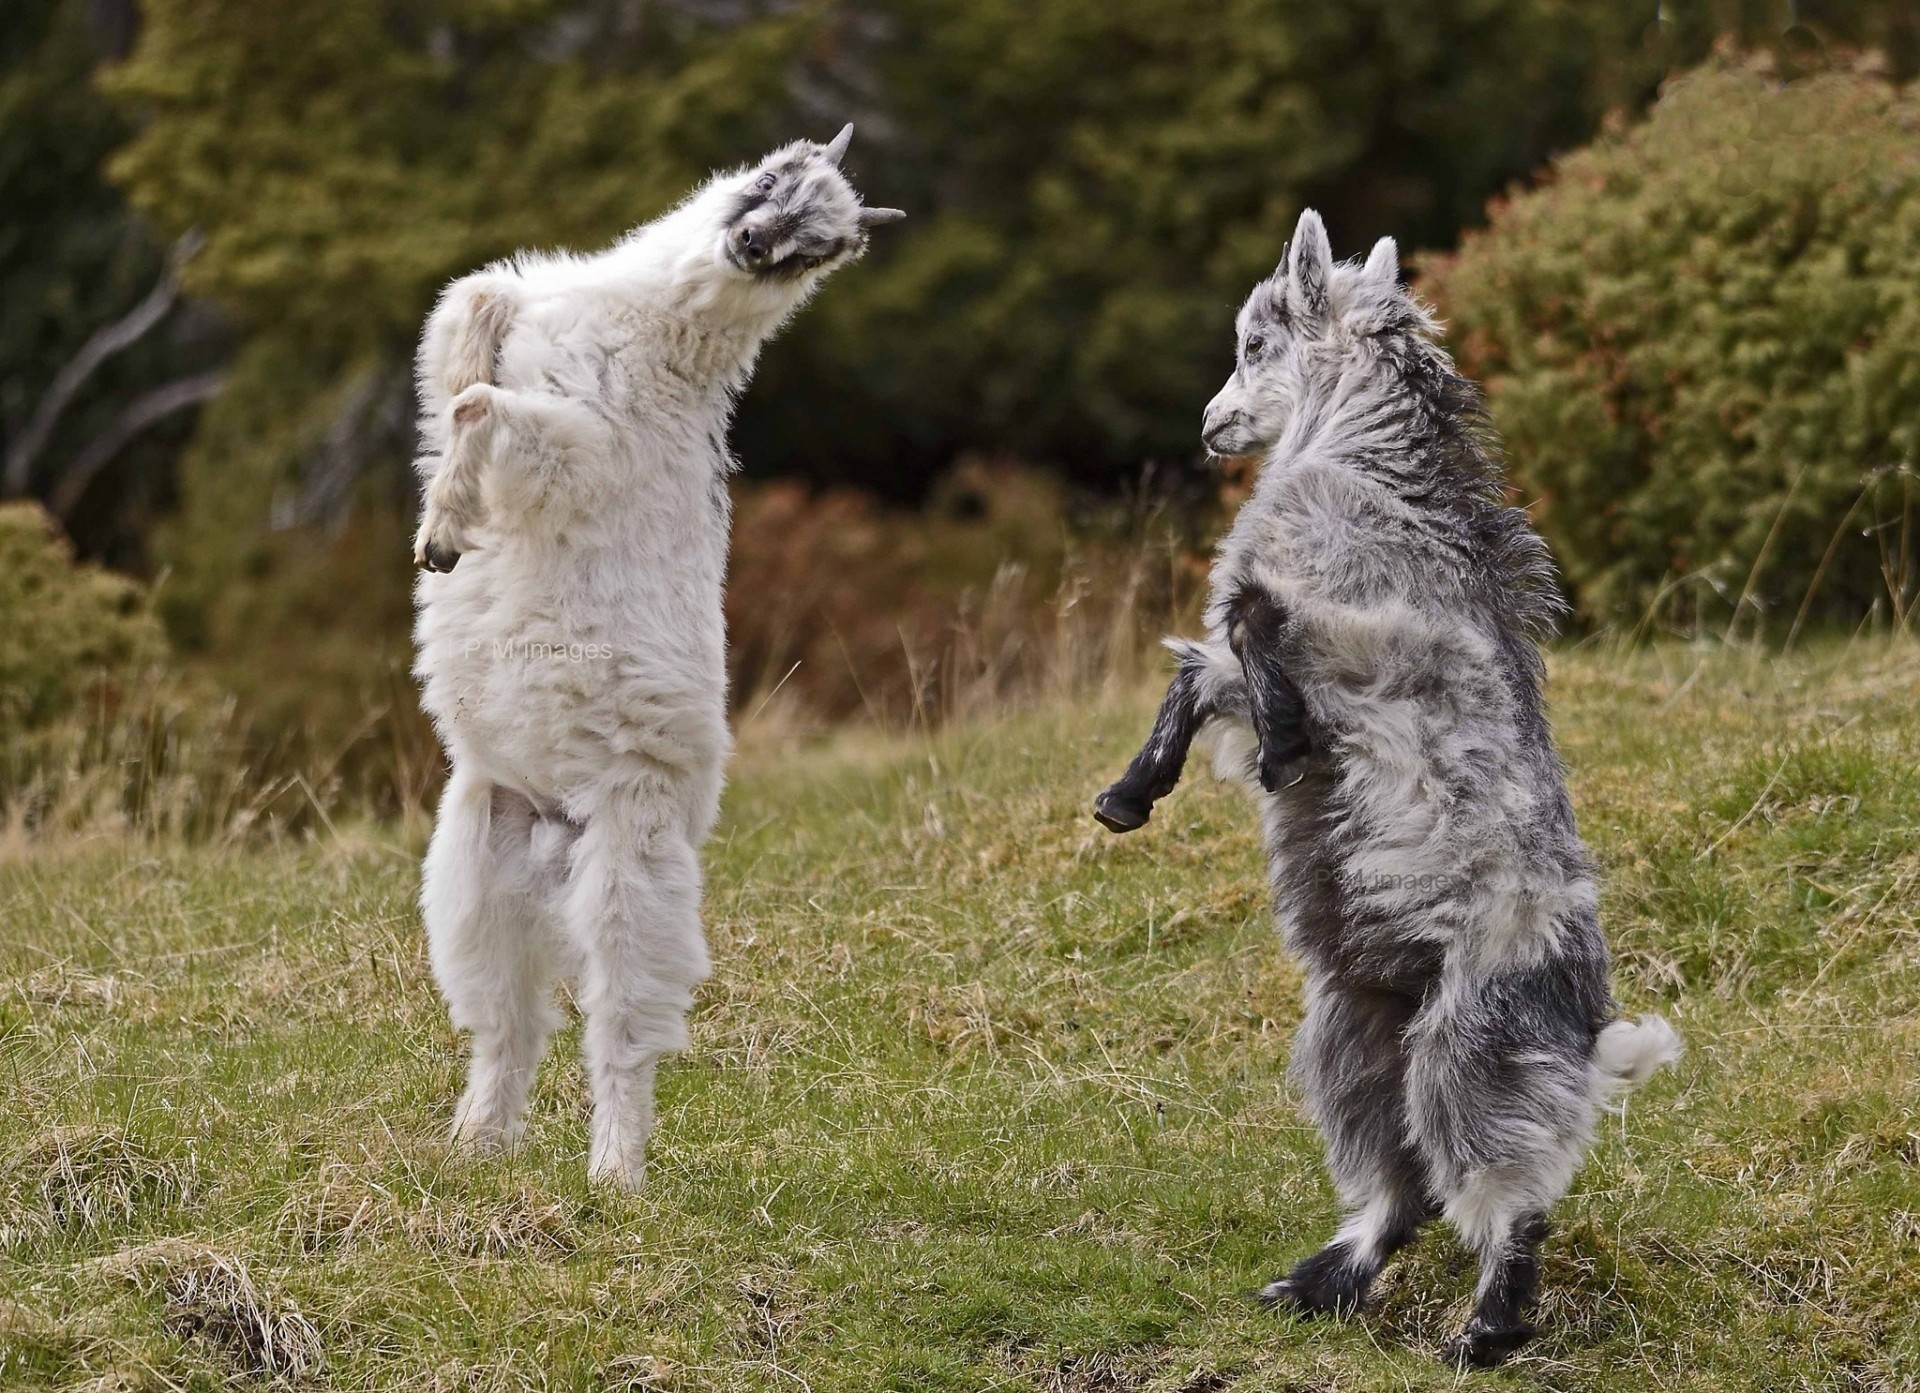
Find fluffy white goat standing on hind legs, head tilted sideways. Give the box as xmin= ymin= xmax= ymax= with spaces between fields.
xmin=415 ymin=127 xmax=900 ymax=1186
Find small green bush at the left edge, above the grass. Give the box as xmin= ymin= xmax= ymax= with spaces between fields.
xmin=0 ymin=503 xmax=165 ymax=746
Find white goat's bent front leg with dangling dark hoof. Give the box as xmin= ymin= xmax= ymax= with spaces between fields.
xmin=413 ymin=382 xmax=612 ymax=572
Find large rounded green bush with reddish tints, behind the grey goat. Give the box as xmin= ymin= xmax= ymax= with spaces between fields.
xmin=1425 ymin=59 xmax=1920 ymax=626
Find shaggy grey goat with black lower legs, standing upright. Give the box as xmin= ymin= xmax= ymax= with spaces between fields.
xmin=1094 ymin=209 xmax=1680 ymax=1366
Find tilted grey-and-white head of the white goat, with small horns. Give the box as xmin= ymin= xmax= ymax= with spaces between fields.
xmin=722 ymin=125 xmax=906 ymax=280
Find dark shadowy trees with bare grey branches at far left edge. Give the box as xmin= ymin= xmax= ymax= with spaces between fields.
xmin=0 ymin=0 xmax=221 ymax=564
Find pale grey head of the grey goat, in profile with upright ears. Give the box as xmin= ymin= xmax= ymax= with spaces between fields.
xmin=1200 ymin=207 xmax=1434 ymax=455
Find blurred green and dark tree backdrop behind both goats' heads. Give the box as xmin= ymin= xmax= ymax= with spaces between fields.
xmin=111 ymin=0 xmax=1910 ymax=551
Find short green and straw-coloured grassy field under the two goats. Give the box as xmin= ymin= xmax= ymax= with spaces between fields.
xmin=0 ymin=647 xmax=1920 ymax=1393
